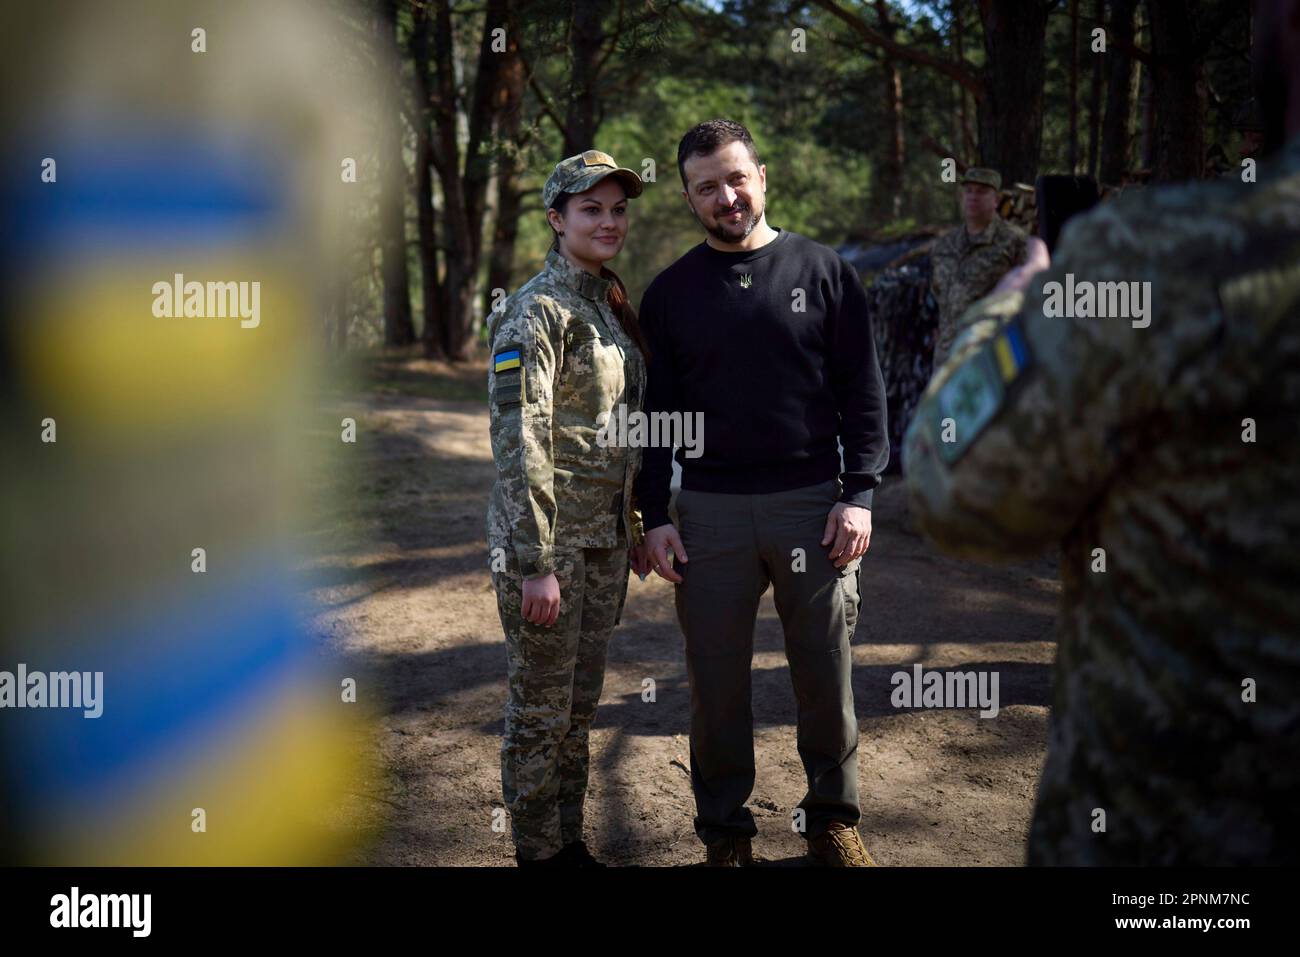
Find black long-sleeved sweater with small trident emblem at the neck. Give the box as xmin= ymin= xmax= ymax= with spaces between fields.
xmin=636 ymin=230 xmax=889 ymax=529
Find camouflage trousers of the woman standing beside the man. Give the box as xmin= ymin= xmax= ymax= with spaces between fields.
xmin=493 ymin=546 xmax=628 ymax=859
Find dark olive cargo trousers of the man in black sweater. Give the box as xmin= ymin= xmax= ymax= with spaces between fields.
xmin=675 ymin=480 xmax=861 ymax=844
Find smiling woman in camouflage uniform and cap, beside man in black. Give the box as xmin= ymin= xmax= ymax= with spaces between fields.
xmin=488 ymin=150 xmax=649 ymax=866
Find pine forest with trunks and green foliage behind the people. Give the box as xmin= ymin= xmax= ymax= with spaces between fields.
xmin=324 ymin=0 xmax=1251 ymax=364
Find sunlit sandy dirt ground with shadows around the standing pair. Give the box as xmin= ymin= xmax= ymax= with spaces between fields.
xmin=308 ymin=369 xmax=1060 ymax=866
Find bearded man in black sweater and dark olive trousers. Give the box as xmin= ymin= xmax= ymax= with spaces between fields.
xmin=636 ymin=120 xmax=889 ymax=866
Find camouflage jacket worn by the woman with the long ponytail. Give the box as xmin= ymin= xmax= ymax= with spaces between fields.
xmin=488 ymin=250 xmax=646 ymax=579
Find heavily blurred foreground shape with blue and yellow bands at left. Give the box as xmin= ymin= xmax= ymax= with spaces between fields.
xmin=0 ymin=0 xmax=377 ymax=866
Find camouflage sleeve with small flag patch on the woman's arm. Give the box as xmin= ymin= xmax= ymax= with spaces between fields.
xmin=489 ymin=304 xmax=562 ymax=579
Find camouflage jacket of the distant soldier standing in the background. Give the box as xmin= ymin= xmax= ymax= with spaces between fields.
xmin=930 ymin=216 xmax=1028 ymax=365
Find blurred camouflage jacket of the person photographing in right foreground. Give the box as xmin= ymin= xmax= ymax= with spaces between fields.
xmin=904 ymin=137 xmax=1300 ymax=865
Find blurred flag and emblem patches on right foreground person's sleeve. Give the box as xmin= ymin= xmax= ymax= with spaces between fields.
xmin=931 ymin=319 xmax=1032 ymax=465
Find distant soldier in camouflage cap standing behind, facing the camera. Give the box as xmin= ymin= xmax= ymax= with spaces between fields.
xmin=930 ymin=166 xmax=1045 ymax=368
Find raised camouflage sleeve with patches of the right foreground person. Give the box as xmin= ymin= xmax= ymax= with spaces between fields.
xmin=904 ymin=197 xmax=1213 ymax=559
